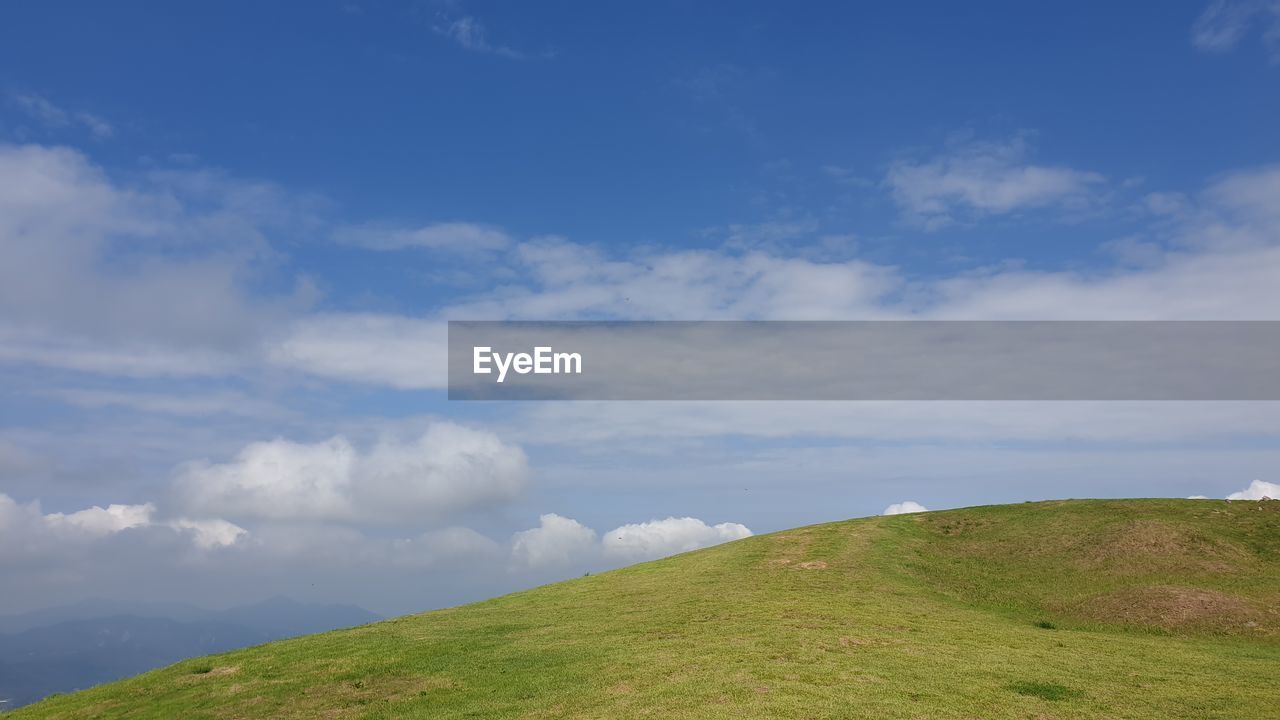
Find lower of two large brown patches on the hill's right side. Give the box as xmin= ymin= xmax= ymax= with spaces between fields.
xmin=1079 ymin=585 xmax=1276 ymax=633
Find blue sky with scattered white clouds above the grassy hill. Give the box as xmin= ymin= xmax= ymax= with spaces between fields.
xmin=0 ymin=0 xmax=1280 ymax=611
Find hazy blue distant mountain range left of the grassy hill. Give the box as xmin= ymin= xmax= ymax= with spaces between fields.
xmin=0 ymin=597 xmax=381 ymax=711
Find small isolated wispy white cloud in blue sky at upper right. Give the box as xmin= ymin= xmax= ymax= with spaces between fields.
xmin=884 ymin=137 xmax=1105 ymax=229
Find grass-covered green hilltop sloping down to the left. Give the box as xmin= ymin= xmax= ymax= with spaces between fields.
xmin=12 ymin=500 xmax=1280 ymax=720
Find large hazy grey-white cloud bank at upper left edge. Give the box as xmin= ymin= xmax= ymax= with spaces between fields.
xmin=0 ymin=143 xmax=310 ymax=377
